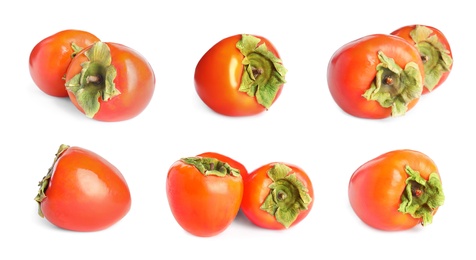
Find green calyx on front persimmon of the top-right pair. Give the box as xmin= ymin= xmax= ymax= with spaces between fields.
xmin=363 ymin=51 xmax=423 ymax=117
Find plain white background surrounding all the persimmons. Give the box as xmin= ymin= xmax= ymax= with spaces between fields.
xmin=0 ymin=0 xmax=476 ymax=260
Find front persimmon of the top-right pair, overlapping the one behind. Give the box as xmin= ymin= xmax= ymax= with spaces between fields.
xmin=327 ymin=34 xmax=424 ymax=119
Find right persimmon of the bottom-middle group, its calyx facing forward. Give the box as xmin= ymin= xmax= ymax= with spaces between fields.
xmin=241 ymin=162 xmax=314 ymax=230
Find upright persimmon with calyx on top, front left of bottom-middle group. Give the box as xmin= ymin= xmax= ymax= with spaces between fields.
xmin=166 ymin=156 xmax=243 ymax=237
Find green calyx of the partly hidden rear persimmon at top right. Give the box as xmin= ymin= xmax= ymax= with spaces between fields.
xmin=410 ymin=25 xmax=453 ymax=91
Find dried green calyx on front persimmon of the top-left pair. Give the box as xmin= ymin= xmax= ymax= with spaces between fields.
xmin=65 ymin=42 xmax=121 ymax=118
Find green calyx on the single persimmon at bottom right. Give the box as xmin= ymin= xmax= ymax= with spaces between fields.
xmin=398 ymin=165 xmax=445 ymax=226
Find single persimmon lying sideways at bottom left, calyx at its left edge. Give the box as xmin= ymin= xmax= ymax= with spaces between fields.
xmin=35 ymin=145 xmax=131 ymax=231
